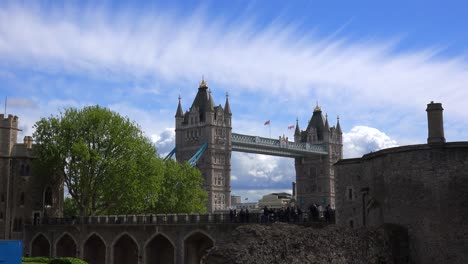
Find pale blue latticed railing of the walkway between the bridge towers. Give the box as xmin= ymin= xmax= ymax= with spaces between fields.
xmin=232 ymin=133 xmax=327 ymax=154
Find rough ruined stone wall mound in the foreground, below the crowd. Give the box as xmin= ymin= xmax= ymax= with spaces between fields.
xmin=204 ymin=223 xmax=408 ymax=264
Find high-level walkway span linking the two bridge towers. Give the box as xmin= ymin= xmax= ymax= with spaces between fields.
xmin=231 ymin=133 xmax=328 ymax=158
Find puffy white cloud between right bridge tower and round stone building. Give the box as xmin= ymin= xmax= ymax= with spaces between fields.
xmin=343 ymin=126 xmax=398 ymax=158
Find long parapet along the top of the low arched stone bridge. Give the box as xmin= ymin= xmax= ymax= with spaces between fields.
xmin=26 ymin=213 xmax=331 ymax=225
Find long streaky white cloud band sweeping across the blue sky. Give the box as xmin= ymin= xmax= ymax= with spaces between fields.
xmin=0 ymin=3 xmax=468 ymax=124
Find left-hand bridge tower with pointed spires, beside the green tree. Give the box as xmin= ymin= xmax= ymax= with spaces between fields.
xmin=175 ymin=80 xmax=232 ymax=212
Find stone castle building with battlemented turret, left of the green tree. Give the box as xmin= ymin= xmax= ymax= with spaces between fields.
xmin=0 ymin=114 xmax=63 ymax=239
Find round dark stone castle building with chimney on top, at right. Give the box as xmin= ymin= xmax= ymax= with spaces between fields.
xmin=335 ymin=102 xmax=468 ymax=263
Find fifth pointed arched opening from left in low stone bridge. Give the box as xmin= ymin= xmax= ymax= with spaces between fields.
xmin=145 ymin=234 xmax=175 ymax=264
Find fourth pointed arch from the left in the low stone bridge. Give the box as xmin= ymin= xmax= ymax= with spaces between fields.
xmin=111 ymin=232 xmax=140 ymax=264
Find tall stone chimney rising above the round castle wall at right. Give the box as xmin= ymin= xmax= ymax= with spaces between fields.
xmin=426 ymin=101 xmax=445 ymax=144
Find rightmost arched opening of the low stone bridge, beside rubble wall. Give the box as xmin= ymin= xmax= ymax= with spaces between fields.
xmin=184 ymin=232 xmax=214 ymax=264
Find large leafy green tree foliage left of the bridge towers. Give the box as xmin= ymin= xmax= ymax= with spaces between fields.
xmin=34 ymin=106 xmax=206 ymax=216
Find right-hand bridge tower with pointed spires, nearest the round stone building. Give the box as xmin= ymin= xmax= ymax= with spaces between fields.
xmin=294 ymin=104 xmax=343 ymax=208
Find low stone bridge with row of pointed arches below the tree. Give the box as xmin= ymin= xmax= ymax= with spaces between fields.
xmin=23 ymin=213 xmax=325 ymax=264
